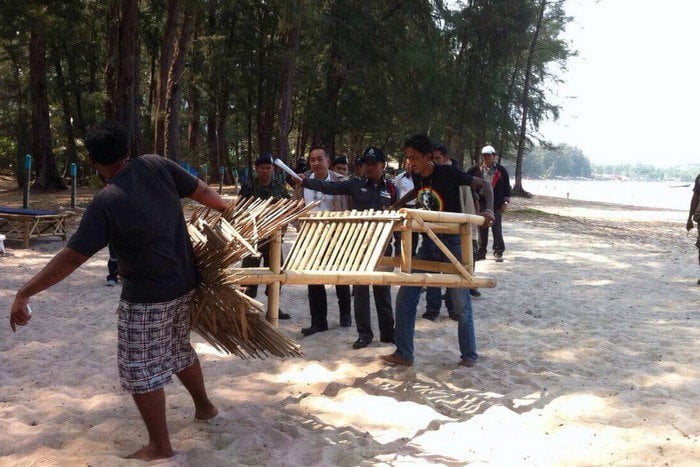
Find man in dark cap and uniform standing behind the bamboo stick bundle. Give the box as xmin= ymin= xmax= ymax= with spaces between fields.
xmin=240 ymin=153 xmax=290 ymax=319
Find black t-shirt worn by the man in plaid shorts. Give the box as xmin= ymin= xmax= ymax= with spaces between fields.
xmin=68 ymin=154 xmax=198 ymax=303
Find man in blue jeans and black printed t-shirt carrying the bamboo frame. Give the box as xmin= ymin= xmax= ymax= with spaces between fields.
xmin=381 ymin=135 xmax=494 ymax=367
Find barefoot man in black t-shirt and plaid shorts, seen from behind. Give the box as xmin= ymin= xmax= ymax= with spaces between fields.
xmin=10 ymin=122 xmax=226 ymax=461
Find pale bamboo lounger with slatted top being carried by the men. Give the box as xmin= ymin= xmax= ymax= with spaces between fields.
xmin=236 ymin=209 xmax=496 ymax=296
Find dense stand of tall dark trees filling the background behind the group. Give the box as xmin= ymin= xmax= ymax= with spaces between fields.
xmin=0 ymin=0 xmax=574 ymax=189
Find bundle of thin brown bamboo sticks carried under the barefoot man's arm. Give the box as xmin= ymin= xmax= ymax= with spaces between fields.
xmin=188 ymin=198 xmax=315 ymax=358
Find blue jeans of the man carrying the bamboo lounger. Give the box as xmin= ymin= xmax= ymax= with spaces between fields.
xmin=394 ymin=235 xmax=479 ymax=361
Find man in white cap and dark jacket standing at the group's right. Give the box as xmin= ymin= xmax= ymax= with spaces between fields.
xmin=467 ymin=146 xmax=510 ymax=263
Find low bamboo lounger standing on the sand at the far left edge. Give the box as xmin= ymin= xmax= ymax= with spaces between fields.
xmin=0 ymin=207 xmax=73 ymax=248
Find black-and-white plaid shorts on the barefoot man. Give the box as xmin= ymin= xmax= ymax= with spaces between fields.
xmin=117 ymin=290 xmax=197 ymax=394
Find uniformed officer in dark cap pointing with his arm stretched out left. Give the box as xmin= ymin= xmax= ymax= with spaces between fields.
xmin=300 ymin=146 xmax=397 ymax=349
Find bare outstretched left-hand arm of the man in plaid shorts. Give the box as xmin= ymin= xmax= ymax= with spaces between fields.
xmin=10 ymin=248 xmax=88 ymax=332
